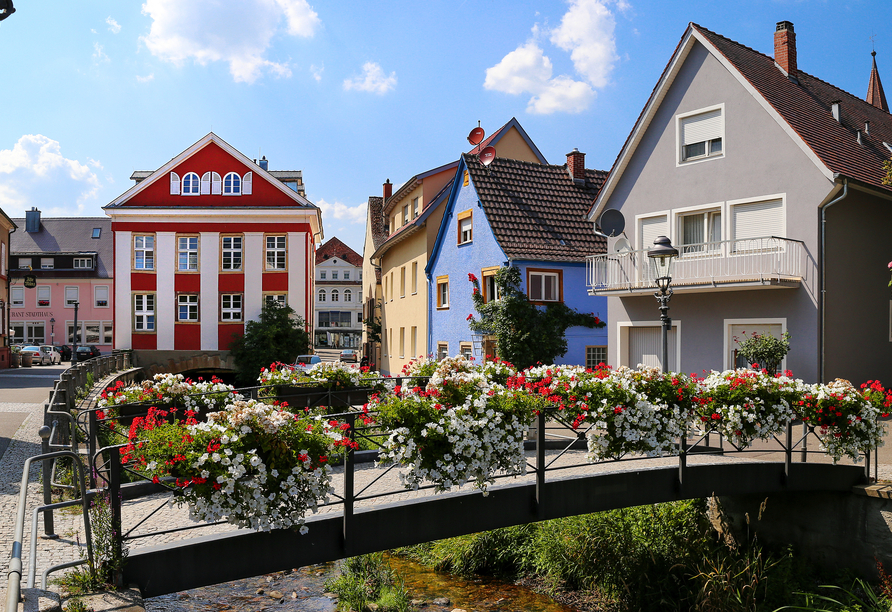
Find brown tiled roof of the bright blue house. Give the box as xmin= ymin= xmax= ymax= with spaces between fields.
xmin=463 ymin=154 xmax=607 ymax=261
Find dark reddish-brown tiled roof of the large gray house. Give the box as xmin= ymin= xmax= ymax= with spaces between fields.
xmin=691 ymin=24 xmax=892 ymax=191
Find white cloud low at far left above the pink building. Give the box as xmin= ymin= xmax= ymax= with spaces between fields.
xmin=0 ymin=134 xmax=102 ymax=217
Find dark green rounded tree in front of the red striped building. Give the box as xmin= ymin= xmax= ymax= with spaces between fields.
xmin=229 ymin=301 xmax=310 ymax=386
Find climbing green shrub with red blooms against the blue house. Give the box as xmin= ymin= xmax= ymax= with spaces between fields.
xmin=468 ymin=266 xmax=606 ymax=369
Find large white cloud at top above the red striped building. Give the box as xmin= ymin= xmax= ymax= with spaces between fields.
xmin=141 ymin=0 xmax=320 ymax=83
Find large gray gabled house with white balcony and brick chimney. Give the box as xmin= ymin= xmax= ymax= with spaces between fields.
xmin=587 ymin=21 xmax=892 ymax=384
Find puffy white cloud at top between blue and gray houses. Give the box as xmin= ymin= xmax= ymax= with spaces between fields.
xmin=483 ymin=0 xmax=630 ymax=114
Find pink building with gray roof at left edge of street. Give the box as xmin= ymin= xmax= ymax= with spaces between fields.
xmin=9 ymin=208 xmax=114 ymax=353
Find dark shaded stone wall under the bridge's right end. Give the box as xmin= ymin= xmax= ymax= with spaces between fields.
xmin=710 ymin=484 xmax=892 ymax=580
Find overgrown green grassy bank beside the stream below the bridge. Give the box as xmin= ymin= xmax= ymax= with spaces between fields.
xmin=396 ymin=500 xmax=892 ymax=612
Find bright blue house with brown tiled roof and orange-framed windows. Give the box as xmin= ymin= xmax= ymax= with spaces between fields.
xmin=425 ymin=150 xmax=607 ymax=366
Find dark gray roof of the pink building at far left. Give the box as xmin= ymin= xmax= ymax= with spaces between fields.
xmin=9 ymin=217 xmax=114 ymax=278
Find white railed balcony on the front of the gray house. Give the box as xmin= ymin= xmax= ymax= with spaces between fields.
xmin=586 ymin=236 xmax=806 ymax=295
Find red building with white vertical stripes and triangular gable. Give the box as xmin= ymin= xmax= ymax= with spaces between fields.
xmin=104 ymin=133 xmax=322 ymax=357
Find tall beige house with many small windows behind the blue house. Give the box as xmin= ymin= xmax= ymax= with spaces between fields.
xmin=363 ymin=119 xmax=547 ymax=375
